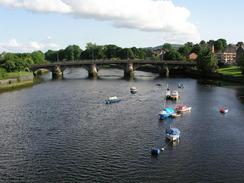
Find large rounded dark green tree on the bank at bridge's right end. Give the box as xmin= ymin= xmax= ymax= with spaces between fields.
xmin=197 ymin=47 xmax=218 ymax=73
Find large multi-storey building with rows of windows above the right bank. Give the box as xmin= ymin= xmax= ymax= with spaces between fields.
xmin=216 ymin=44 xmax=237 ymax=64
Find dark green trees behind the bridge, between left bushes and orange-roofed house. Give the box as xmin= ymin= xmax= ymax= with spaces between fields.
xmin=45 ymin=43 xmax=154 ymax=62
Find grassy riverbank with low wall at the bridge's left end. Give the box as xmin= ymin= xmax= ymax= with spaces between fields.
xmin=0 ymin=72 xmax=34 ymax=92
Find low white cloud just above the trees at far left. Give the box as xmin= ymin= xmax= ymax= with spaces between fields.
xmin=0 ymin=38 xmax=60 ymax=52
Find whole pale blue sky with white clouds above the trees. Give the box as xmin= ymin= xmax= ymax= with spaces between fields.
xmin=0 ymin=0 xmax=244 ymax=52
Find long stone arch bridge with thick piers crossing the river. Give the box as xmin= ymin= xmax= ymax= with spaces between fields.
xmin=31 ymin=60 xmax=196 ymax=79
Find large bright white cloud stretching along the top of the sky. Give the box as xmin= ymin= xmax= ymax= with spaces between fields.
xmin=0 ymin=0 xmax=200 ymax=41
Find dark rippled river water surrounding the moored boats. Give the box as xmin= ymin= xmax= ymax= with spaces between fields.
xmin=0 ymin=69 xmax=244 ymax=183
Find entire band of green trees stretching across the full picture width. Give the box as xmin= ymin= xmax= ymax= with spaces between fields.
xmin=0 ymin=38 xmax=244 ymax=77
